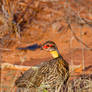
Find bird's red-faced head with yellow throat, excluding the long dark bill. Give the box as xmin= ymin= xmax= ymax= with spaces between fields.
xmin=41 ymin=41 xmax=60 ymax=58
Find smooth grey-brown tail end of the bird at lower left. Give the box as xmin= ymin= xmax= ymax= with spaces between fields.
xmin=15 ymin=67 xmax=39 ymax=88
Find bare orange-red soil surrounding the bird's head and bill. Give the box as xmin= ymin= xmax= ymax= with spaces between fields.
xmin=0 ymin=0 xmax=92 ymax=91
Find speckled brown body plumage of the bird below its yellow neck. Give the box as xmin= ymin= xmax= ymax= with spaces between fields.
xmin=15 ymin=41 xmax=69 ymax=92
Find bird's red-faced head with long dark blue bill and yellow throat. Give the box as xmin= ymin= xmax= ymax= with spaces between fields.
xmin=17 ymin=41 xmax=60 ymax=58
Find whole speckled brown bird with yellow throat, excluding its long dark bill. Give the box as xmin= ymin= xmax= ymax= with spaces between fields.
xmin=15 ymin=40 xmax=70 ymax=92
